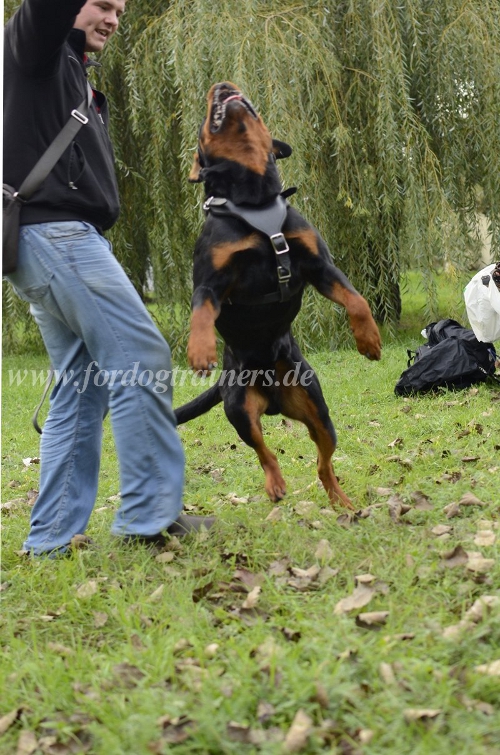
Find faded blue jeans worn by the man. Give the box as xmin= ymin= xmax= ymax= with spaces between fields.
xmin=7 ymin=221 xmax=184 ymax=555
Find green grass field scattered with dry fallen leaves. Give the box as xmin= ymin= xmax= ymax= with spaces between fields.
xmin=0 ymin=274 xmax=500 ymax=755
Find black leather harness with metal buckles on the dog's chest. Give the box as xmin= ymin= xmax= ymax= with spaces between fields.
xmin=203 ymin=190 xmax=296 ymax=305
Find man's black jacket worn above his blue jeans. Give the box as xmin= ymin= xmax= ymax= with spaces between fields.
xmin=3 ymin=0 xmax=119 ymax=231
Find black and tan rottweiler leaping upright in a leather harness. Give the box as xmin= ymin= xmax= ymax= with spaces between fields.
xmin=175 ymin=82 xmax=381 ymax=509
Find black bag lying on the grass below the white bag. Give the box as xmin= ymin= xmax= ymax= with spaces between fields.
xmin=394 ymin=319 xmax=496 ymax=396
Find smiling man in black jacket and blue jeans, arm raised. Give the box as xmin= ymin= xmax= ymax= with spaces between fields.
xmin=4 ymin=0 xmax=212 ymax=556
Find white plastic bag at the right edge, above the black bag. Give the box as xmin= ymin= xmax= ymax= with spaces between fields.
xmin=464 ymin=264 xmax=500 ymax=342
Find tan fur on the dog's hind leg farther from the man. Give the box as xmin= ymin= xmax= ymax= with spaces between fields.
xmin=280 ymin=385 xmax=354 ymax=510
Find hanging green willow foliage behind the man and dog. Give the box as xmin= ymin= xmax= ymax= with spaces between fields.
xmin=6 ymin=0 xmax=500 ymax=348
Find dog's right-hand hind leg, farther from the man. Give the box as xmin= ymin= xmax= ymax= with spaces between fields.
xmin=277 ymin=363 xmax=354 ymax=510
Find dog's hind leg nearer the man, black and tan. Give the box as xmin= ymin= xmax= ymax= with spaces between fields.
xmin=224 ymin=387 xmax=286 ymax=501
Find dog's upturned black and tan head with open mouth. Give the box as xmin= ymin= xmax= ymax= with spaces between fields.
xmin=189 ymin=81 xmax=292 ymax=204
